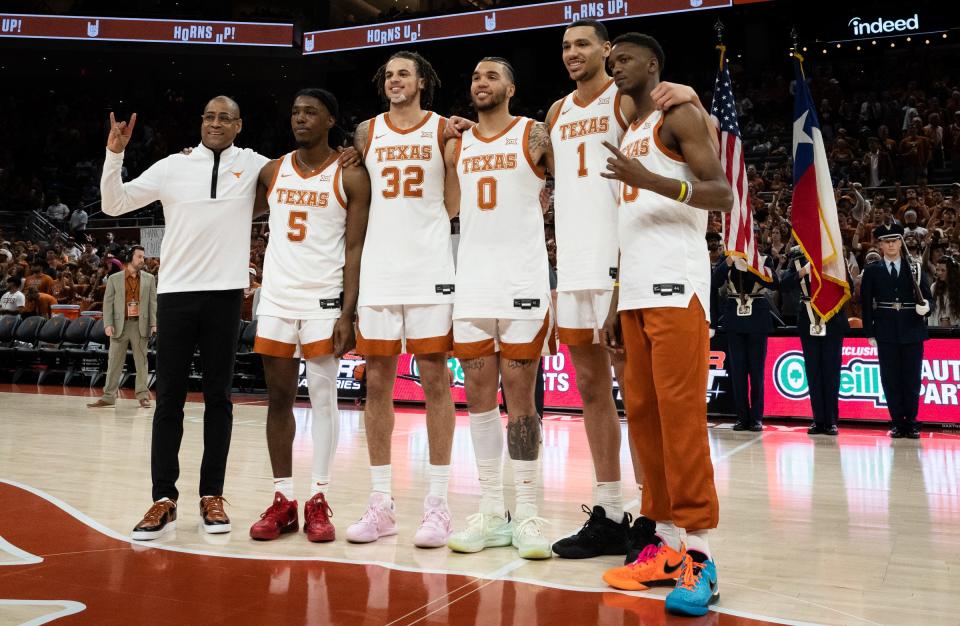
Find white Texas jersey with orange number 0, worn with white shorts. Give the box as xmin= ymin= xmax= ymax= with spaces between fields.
xmin=453 ymin=117 xmax=550 ymax=319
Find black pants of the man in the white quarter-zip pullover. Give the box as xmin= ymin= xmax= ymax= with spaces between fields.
xmin=150 ymin=289 xmax=243 ymax=501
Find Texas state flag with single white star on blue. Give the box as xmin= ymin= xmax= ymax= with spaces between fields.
xmin=790 ymin=55 xmax=850 ymax=319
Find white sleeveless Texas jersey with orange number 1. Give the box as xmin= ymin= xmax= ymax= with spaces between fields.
xmin=550 ymin=79 xmax=627 ymax=291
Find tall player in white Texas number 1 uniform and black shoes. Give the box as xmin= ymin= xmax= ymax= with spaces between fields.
xmin=546 ymin=20 xmax=709 ymax=561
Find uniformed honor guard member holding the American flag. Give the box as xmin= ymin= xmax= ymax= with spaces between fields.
xmin=713 ymin=249 xmax=780 ymax=432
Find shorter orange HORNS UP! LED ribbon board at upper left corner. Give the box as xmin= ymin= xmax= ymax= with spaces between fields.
xmin=0 ymin=13 xmax=293 ymax=47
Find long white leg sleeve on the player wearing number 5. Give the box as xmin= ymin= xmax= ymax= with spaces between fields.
xmin=307 ymin=355 xmax=340 ymax=495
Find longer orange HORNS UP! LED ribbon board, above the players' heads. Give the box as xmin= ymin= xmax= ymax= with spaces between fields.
xmin=303 ymin=0 xmax=734 ymax=54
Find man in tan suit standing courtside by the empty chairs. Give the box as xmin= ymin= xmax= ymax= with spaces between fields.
xmin=87 ymin=246 xmax=157 ymax=409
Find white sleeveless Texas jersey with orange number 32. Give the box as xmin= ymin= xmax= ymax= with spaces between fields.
xmin=359 ymin=112 xmax=454 ymax=306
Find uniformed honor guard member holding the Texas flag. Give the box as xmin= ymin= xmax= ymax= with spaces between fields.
xmin=780 ymin=246 xmax=853 ymax=435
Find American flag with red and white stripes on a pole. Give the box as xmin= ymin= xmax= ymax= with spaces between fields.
xmin=710 ymin=46 xmax=773 ymax=281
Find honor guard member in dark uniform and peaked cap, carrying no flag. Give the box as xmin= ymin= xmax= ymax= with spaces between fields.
xmin=860 ymin=224 xmax=931 ymax=439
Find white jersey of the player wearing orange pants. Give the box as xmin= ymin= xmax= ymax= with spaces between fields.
xmin=619 ymin=111 xmax=710 ymax=320
